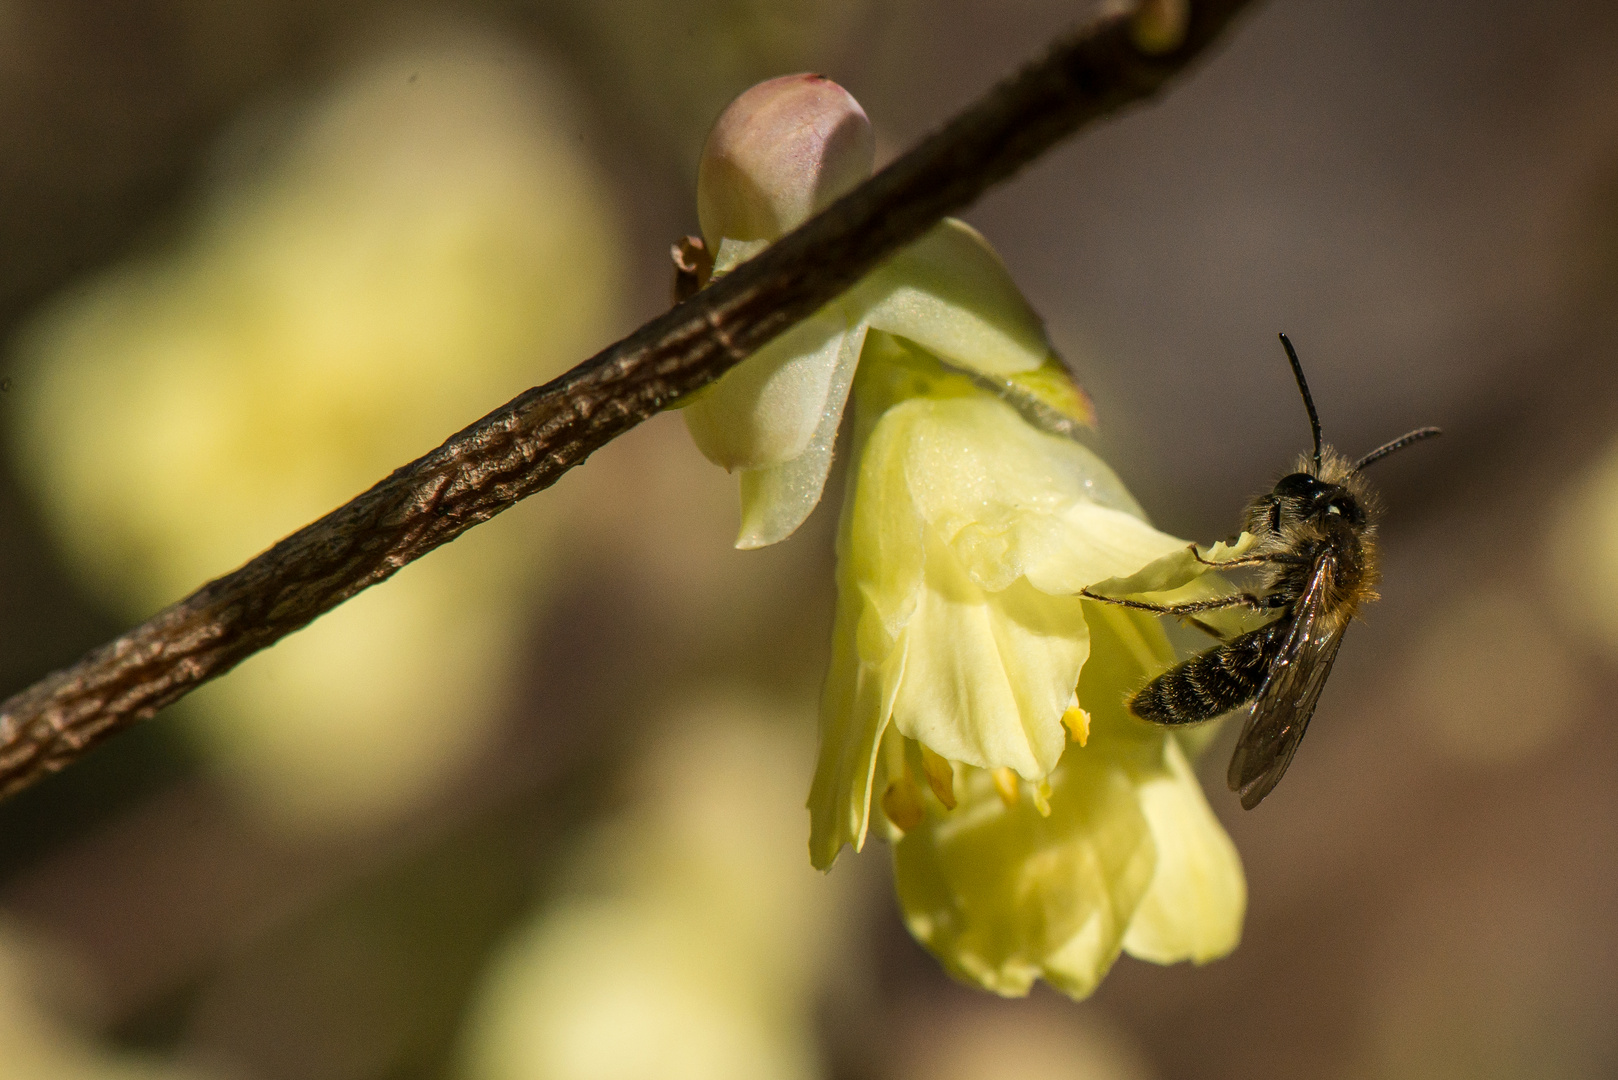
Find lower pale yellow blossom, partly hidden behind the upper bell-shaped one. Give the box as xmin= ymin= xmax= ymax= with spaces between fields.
xmin=890 ymin=601 xmax=1246 ymax=997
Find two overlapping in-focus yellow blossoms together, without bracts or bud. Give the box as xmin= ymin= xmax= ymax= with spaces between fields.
xmin=809 ymin=344 xmax=1246 ymax=996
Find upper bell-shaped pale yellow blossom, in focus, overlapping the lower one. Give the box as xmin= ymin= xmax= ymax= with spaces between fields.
xmin=811 ymin=335 xmax=1184 ymax=866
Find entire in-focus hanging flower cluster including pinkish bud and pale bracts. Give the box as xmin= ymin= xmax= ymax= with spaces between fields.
xmin=686 ymin=76 xmax=1246 ymax=996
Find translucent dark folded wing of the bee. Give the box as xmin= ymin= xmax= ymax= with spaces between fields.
xmin=1225 ymin=555 xmax=1348 ymax=810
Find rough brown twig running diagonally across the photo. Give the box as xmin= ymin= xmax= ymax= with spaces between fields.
xmin=0 ymin=0 xmax=1246 ymax=795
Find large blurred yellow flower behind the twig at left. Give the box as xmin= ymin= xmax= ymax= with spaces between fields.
xmin=15 ymin=31 xmax=618 ymax=831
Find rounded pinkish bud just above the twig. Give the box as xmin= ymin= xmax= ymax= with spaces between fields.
xmin=697 ymin=73 xmax=875 ymax=251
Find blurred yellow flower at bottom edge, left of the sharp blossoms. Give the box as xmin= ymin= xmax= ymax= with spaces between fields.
xmin=464 ymin=695 xmax=853 ymax=1080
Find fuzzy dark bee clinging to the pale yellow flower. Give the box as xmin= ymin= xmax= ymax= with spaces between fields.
xmin=1081 ymin=334 xmax=1440 ymax=810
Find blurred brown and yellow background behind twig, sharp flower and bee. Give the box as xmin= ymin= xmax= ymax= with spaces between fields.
xmin=0 ymin=0 xmax=1618 ymax=1080
